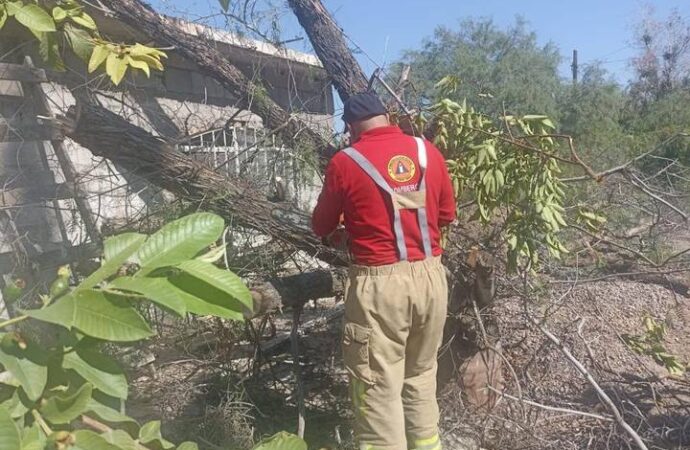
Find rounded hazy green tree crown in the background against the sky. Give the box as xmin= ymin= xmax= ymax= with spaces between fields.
xmin=402 ymin=18 xmax=561 ymax=118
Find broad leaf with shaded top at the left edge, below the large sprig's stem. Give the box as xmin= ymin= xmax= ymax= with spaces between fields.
xmin=0 ymin=334 xmax=48 ymax=400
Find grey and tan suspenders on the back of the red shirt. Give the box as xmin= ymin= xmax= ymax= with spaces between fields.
xmin=342 ymin=137 xmax=432 ymax=261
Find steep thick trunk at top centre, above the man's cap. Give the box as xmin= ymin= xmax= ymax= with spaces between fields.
xmin=288 ymin=0 xmax=367 ymax=101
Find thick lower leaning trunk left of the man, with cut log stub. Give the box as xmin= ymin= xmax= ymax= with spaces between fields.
xmin=60 ymin=101 xmax=346 ymax=313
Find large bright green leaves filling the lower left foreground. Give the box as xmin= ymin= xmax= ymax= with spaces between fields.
xmin=0 ymin=213 xmax=255 ymax=450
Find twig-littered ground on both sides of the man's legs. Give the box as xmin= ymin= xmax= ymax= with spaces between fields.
xmin=129 ymin=281 xmax=690 ymax=450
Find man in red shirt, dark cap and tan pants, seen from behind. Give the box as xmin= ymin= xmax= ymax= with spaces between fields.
xmin=312 ymin=92 xmax=455 ymax=450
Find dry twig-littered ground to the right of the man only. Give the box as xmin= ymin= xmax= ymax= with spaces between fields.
xmin=442 ymin=281 xmax=690 ymax=449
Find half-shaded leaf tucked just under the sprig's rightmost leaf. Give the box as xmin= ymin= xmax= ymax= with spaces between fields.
xmin=169 ymin=272 xmax=245 ymax=320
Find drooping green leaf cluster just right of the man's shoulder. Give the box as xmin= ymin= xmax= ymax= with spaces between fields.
xmin=414 ymin=92 xmax=567 ymax=269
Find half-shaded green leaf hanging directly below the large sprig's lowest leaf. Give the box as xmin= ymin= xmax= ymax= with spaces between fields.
xmin=62 ymin=348 xmax=128 ymax=399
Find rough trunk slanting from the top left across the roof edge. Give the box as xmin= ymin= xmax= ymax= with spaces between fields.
xmin=101 ymin=0 xmax=332 ymax=160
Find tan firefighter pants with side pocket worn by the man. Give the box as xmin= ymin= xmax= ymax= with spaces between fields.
xmin=343 ymin=257 xmax=448 ymax=450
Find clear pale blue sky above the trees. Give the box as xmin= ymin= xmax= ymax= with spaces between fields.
xmin=151 ymin=0 xmax=690 ymax=82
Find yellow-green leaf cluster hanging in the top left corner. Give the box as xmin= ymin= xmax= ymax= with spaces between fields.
xmin=0 ymin=0 xmax=167 ymax=85
